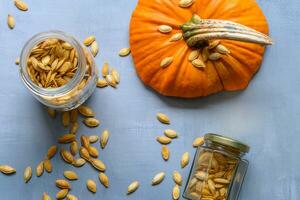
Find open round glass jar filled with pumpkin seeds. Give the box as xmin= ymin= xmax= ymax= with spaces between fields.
xmin=20 ymin=31 xmax=98 ymax=111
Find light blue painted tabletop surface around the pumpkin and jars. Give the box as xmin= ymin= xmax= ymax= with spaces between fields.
xmin=0 ymin=0 xmax=300 ymax=200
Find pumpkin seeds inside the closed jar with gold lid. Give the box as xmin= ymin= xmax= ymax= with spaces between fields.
xmin=187 ymin=150 xmax=237 ymax=200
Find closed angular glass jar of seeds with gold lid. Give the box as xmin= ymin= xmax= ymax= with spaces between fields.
xmin=183 ymin=133 xmax=250 ymax=200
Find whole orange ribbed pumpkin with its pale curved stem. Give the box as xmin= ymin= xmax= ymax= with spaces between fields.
xmin=130 ymin=0 xmax=272 ymax=98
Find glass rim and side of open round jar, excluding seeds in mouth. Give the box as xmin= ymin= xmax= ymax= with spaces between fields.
xmin=20 ymin=31 xmax=98 ymax=111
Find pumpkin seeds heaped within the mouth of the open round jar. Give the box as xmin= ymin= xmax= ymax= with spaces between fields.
xmin=27 ymin=38 xmax=82 ymax=88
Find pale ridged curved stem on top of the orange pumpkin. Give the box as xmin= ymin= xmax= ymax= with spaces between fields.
xmin=181 ymin=15 xmax=273 ymax=47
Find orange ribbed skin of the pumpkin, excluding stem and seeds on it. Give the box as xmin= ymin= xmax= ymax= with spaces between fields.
xmin=130 ymin=0 xmax=269 ymax=98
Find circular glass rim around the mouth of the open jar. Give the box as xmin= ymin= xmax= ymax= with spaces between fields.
xmin=20 ymin=31 xmax=87 ymax=96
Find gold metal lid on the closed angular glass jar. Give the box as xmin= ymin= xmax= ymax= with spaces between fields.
xmin=204 ymin=133 xmax=250 ymax=153
